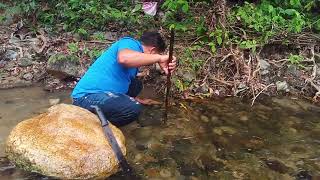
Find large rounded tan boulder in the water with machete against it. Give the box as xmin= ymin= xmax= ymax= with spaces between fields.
xmin=6 ymin=104 xmax=126 ymax=179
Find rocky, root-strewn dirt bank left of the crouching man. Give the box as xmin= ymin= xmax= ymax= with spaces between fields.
xmin=0 ymin=23 xmax=118 ymax=91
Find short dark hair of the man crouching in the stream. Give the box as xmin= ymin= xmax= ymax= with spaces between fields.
xmin=140 ymin=31 xmax=166 ymax=53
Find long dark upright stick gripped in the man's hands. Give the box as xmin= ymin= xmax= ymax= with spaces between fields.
xmin=164 ymin=28 xmax=174 ymax=124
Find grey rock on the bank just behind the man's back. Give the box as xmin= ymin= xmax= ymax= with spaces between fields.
xmin=47 ymin=54 xmax=83 ymax=79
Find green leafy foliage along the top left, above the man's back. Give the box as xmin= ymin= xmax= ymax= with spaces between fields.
xmin=0 ymin=0 xmax=141 ymax=31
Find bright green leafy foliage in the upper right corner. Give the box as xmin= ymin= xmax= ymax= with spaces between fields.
xmin=229 ymin=0 xmax=320 ymax=48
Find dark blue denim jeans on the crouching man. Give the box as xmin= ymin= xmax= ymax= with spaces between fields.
xmin=73 ymin=80 xmax=142 ymax=126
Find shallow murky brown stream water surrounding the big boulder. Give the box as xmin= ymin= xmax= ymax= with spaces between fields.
xmin=0 ymin=88 xmax=320 ymax=180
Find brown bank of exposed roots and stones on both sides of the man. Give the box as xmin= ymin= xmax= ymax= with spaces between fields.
xmin=0 ymin=26 xmax=320 ymax=102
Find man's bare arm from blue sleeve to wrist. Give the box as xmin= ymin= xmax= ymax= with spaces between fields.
xmin=118 ymin=49 xmax=161 ymax=67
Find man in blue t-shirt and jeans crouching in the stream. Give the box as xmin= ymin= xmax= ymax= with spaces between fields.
xmin=71 ymin=32 xmax=176 ymax=126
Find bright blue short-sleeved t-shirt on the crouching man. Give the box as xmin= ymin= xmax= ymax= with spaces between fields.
xmin=71 ymin=37 xmax=143 ymax=98
